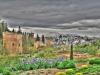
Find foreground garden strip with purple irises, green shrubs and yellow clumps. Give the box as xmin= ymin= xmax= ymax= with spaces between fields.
xmin=0 ymin=57 xmax=100 ymax=75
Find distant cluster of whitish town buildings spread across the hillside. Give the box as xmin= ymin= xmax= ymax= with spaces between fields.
xmin=46 ymin=34 xmax=99 ymax=45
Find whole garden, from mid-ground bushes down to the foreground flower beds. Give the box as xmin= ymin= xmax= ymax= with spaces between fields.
xmin=0 ymin=41 xmax=100 ymax=75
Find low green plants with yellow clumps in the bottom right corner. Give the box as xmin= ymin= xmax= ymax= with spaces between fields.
xmin=56 ymin=65 xmax=100 ymax=75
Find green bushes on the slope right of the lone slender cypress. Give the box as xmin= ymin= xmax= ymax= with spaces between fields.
xmin=74 ymin=40 xmax=100 ymax=56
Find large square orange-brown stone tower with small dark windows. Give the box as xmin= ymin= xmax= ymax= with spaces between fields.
xmin=3 ymin=32 xmax=22 ymax=55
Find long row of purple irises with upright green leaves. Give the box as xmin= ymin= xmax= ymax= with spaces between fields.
xmin=11 ymin=57 xmax=67 ymax=71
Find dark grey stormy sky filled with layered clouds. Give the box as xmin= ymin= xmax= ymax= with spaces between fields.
xmin=0 ymin=0 xmax=100 ymax=36
